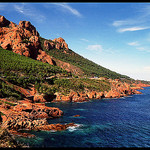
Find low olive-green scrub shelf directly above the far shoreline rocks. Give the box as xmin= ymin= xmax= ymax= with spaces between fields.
xmin=36 ymin=78 xmax=110 ymax=95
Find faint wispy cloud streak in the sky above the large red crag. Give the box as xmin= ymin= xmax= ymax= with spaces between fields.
xmin=14 ymin=3 xmax=46 ymax=22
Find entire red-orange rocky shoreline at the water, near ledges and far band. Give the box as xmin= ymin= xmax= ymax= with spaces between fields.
xmin=0 ymin=80 xmax=150 ymax=137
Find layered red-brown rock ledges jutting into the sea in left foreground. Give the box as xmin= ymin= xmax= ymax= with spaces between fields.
xmin=0 ymin=99 xmax=76 ymax=137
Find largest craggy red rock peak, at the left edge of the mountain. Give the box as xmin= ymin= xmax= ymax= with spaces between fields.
xmin=0 ymin=16 xmax=54 ymax=65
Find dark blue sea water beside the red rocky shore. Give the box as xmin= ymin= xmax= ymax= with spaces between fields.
xmin=15 ymin=87 xmax=150 ymax=147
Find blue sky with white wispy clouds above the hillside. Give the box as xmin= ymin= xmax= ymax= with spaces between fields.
xmin=0 ymin=3 xmax=150 ymax=81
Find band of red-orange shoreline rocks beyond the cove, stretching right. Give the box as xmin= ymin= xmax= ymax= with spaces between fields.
xmin=53 ymin=80 xmax=145 ymax=102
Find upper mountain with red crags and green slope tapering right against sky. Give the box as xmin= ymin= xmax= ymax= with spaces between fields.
xmin=0 ymin=15 xmax=130 ymax=79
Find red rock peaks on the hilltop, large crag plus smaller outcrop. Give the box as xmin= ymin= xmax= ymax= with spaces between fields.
xmin=0 ymin=16 xmax=76 ymax=74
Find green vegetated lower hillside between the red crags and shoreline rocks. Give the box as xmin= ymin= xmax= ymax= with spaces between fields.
xmin=0 ymin=48 xmax=110 ymax=99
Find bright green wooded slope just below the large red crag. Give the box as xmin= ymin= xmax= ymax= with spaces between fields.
xmin=0 ymin=48 xmax=67 ymax=78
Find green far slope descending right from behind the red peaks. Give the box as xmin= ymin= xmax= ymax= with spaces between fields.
xmin=40 ymin=37 xmax=130 ymax=79
